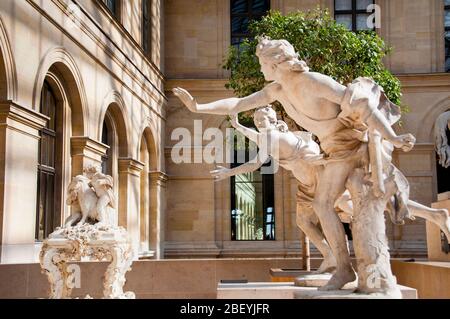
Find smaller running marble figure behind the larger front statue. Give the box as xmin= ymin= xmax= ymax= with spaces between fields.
xmin=211 ymin=107 xmax=450 ymax=273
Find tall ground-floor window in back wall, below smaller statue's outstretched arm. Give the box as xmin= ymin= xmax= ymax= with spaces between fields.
xmin=231 ymin=139 xmax=275 ymax=241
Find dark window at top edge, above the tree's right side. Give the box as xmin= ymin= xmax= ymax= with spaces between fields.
xmin=334 ymin=0 xmax=374 ymax=31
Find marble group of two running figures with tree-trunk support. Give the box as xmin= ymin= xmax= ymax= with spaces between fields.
xmin=173 ymin=37 xmax=450 ymax=298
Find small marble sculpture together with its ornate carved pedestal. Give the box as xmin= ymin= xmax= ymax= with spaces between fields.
xmin=39 ymin=165 xmax=135 ymax=299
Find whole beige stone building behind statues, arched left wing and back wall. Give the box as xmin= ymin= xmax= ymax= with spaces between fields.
xmin=0 ymin=0 xmax=450 ymax=262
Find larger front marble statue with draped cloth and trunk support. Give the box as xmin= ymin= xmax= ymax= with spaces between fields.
xmin=173 ymin=38 xmax=415 ymax=297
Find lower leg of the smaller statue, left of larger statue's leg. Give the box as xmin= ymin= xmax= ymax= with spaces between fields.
xmin=296 ymin=203 xmax=336 ymax=274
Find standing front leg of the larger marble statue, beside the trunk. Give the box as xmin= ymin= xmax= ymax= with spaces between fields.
xmin=313 ymin=161 xmax=356 ymax=290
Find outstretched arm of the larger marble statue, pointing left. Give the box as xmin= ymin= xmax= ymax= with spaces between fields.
xmin=172 ymin=84 xmax=276 ymax=115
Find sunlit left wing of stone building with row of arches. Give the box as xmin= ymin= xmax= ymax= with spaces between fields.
xmin=0 ymin=0 xmax=167 ymax=262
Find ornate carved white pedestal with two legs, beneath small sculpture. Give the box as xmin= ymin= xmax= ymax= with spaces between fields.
xmin=39 ymin=224 xmax=135 ymax=299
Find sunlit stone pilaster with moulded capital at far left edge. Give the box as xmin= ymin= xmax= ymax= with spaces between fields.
xmin=0 ymin=101 xmax=48 ymax=245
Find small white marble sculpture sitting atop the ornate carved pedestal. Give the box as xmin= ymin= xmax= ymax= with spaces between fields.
xmin=64 ymin=165 xmax=117 ymax=227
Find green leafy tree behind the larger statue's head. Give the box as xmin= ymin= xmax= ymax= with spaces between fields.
xmin=223 ymin=8 xmax=401 ymax=126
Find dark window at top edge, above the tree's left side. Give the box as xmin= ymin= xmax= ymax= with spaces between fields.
xmin=230 ymin=0 xmax=270 ymax=49
